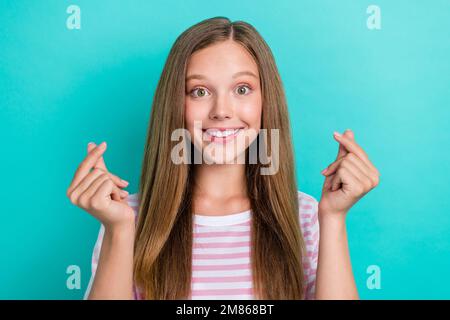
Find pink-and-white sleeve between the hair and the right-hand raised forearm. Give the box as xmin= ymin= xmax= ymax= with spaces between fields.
xmin=298 ymin=191 xmax=320 ymax=300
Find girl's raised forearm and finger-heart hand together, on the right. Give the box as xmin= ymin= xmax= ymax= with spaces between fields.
xmin=316 ymin=129 xmax=380 ymax=299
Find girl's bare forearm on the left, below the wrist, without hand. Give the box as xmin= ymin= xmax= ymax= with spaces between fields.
xmin=88 ymin=226 xmax=135 ymax=299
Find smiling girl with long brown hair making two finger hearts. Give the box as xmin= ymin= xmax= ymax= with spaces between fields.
xmin=67 ymin=17 xmax=379 ymax=299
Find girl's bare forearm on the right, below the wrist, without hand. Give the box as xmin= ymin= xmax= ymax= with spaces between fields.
xmin=315 ymin=211 xmax=359 ymax=299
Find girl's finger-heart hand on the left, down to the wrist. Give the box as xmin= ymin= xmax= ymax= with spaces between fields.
xmin=67 ymin=142 xmax=135 ymax=228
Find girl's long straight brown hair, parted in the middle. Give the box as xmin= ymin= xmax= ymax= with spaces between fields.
xmin=134 ymin=17 xmax=305 ymax=299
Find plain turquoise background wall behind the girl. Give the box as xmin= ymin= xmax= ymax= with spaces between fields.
xmin=0 ymin=0 xmax=450 ymax=299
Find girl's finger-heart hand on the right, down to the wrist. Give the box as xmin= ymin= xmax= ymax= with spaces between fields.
xmin=319 ymin=129 xmax=380 ymax=217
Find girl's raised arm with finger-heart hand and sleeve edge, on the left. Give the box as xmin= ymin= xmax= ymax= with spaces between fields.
xmin=67 ymin=142 xmax=135 ymax=299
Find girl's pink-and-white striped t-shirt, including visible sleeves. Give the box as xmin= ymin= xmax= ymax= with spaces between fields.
xmin=84 ymin=191 xmax=319 ymax=300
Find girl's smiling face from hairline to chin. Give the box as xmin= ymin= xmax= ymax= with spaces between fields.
xmin=185 ymin=40 xmax=262 ymax=164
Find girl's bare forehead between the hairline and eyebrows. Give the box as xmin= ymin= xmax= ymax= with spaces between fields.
xmin=186 ymin=40 xmax=258 ymax=77
